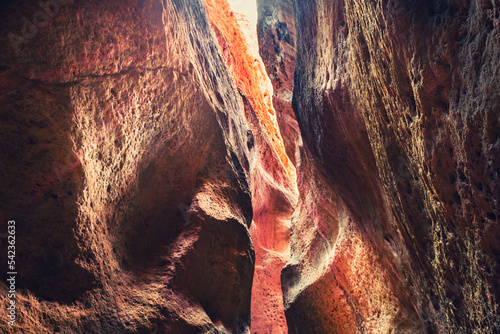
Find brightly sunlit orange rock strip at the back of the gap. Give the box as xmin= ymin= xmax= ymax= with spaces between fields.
xmin=205 ymin=0 xmax=297 ymax=333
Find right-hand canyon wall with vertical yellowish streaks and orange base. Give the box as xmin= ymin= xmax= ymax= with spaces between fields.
xmin=282 ymin=0 xmax=500 ymax=333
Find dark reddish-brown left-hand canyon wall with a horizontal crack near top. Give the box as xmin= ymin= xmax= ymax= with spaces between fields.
xmin=0 ymin=0 xmax=254 ymax=333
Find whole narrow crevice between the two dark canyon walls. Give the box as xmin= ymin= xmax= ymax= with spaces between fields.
xmin=205 ymin=0 xmax=300 ymax=334
